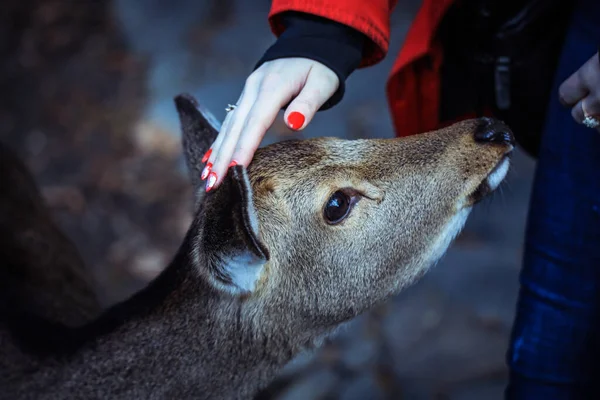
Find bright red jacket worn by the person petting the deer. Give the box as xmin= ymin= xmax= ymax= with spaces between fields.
xmin=269 ymin=0 xmax=454 ymax=136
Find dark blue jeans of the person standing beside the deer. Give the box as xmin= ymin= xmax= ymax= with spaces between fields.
xmin=505 ymin=0 xmax=600 ymax=400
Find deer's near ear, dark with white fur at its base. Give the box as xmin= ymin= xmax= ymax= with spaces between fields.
xmin=202 ymin=165 xmax=269 ymax=292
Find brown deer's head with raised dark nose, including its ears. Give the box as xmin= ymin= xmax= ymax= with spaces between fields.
xmin=177 ymin=96 xmax=513 ymax=329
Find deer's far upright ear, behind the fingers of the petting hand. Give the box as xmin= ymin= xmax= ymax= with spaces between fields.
xmin=175 ymin=93 xmax=221 ymax=204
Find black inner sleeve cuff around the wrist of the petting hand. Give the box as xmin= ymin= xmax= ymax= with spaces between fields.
xmin=254 ymin=11 xmax=366 ymax=111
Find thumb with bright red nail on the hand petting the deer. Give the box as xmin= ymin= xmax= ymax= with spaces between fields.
xmin=284 ymin=69 xmax=339 ymax=130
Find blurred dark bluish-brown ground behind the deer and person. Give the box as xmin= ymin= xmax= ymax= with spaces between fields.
xmin=0 ymin=0 xmax=534 ymax=400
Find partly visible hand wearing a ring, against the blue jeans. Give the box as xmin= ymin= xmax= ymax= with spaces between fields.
xmin=558 ymin=53 xmax=600 ymax=132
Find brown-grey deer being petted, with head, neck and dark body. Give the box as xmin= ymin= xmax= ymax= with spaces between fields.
xmin=0 ymin=93 xmax=515 ymax=399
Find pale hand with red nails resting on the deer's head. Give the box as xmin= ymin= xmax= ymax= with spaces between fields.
xmin=201 ymin=58 xmax=340 ymax=192
